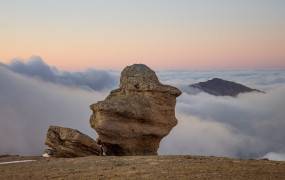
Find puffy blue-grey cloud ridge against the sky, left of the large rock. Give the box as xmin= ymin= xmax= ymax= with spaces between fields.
xmin=5 ymin=56 xmax=117 ymax=91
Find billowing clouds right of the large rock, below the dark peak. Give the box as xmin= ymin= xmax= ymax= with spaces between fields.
xmin=160 ymin=87 xmax=285 ymax=158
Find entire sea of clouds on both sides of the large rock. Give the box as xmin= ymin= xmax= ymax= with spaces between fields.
xmin=0 ymin=57 xmax=285 ymax=160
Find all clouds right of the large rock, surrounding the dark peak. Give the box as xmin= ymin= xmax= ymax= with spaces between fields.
xmin=160 ymin=70 xmax=285 ymax=158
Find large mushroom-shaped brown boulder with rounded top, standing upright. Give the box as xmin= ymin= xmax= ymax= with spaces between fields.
xmin=90 ymin=64 xmax=181 ymax=155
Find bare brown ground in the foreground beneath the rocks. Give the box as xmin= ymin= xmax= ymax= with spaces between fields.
xmin=0 ymin=156 xmax=285 ymax=180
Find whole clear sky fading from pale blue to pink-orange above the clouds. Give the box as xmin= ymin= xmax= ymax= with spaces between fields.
xmin=0 ymin=0 xmax=285 ymax=70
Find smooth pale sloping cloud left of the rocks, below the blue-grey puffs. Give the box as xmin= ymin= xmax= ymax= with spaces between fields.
xmin=0 ymin=67 xmax=106 ymax=154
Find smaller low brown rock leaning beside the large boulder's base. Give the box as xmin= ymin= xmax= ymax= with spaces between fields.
xmin=45 ymin=126 xmax=102 ymax=157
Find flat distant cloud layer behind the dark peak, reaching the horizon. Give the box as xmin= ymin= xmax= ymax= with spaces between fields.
xmin=158 ymin=69 xmax=285 ymax=91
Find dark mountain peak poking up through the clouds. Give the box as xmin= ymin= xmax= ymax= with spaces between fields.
xmin=190 ymin=78 xmax=265 ymax=97
